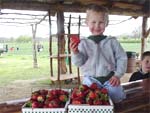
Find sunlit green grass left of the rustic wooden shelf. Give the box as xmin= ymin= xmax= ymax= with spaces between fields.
xmin=0 ymin=55 xmax=50 ymax=85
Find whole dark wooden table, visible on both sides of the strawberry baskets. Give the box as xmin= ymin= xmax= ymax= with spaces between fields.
xmin=0 ymin=79 xmax=150 ymax=113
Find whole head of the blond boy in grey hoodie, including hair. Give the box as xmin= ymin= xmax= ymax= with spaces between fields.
xmin=86 ymin=4 xmax=108 ymax=35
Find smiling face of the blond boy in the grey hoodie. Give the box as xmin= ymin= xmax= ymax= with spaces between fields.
xmin=86 ymin=11 xmax=106 ymax=35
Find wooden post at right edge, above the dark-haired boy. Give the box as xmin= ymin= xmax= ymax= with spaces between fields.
xmin=141 ymin=16 xmax=147 ymax=54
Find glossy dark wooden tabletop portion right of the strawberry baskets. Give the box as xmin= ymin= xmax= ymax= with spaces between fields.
xmin=114 ymin=79 xmax=150 ymax=113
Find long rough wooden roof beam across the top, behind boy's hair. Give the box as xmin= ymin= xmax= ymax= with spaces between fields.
xmin=0 ymin=0 xmax=149 ymax=16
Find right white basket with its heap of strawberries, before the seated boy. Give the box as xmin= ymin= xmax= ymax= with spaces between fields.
xmin=68 ymin=83 xmax=114 ymax=113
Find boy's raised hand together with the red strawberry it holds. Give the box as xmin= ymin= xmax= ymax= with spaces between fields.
xmin=70 ymin=35 xmax=80 ymax=54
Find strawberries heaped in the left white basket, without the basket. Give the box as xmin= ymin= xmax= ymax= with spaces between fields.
xmin=25 ymin=89 xmax=69 ymax=108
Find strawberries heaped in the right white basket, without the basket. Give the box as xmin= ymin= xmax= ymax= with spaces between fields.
xmin=71 ymin=83 xmax=110 ymax=105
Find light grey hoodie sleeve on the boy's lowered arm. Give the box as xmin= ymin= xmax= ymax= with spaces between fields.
xmin=113 ymin=39 xmax=127 ymax=78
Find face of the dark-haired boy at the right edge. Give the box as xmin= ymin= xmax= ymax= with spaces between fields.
xmin=141 ymin=56 xmax=150 ymax=73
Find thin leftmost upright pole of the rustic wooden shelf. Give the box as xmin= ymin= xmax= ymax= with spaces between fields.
xmin=48 ymin=11 xmax=53 ymax=77
